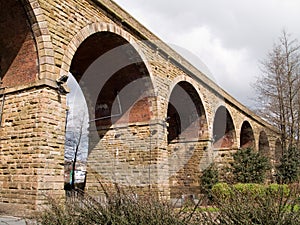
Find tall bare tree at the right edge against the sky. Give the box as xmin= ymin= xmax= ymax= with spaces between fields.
xmin=254 ymin=31 xmax=300 ymax=149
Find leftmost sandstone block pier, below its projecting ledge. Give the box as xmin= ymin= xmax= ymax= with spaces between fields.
xmin=0 ymin=87 xmax=65 ymax=215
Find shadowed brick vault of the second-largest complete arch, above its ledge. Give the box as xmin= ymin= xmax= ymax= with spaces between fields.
xmin=166 ymin=81 xmax=208 ymax=143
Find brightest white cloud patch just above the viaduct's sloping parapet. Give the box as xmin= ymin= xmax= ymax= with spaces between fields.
xmin=171 ymin=27 xmax=258 ymax=104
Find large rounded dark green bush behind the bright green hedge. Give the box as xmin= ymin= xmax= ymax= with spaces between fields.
xmin=231 ymin=148 xmax=270 ymax=183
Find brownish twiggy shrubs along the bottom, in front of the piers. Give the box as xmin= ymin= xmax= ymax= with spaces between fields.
xmin=35 ymin=186 xmax=205 ymax=225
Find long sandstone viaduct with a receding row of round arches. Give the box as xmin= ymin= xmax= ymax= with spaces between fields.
xmin=0 ymin=0 xmax=281 ymax=214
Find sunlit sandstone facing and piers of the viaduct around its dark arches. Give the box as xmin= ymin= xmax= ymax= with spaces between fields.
xmin=0 ymin=0 xmax=277 ymax=214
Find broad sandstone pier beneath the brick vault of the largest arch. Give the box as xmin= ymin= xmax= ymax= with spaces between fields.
xmin=87 ymin=121 xmax=169 ymax=197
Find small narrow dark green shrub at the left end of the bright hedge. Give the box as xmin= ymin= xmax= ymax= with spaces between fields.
xmin=200 ymin=164 xmax=219 ymax=200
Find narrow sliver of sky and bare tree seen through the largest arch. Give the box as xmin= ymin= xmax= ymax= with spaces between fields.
xmin=64 ymin=73 xmax=89 ymax=191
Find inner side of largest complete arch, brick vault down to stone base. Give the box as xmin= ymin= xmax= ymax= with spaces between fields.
xmin=66 ymin=31 xmax=156 ymax=193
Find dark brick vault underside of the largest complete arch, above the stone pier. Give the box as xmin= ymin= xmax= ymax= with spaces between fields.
xmin=70 ymin=31 xmax=155 ymax=134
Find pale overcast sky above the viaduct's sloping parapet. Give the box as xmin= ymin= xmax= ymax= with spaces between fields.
xmin=115 ymin=0 xmax=300 ymax=108
